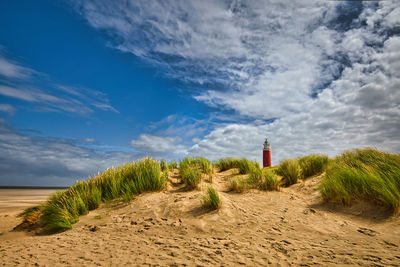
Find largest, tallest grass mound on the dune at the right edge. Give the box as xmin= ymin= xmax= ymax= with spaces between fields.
xmin=319 ymin=148 xmax=400 ymax=213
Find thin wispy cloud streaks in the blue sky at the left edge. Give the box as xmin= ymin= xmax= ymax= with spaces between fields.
xmin=0 ymin=50 xmax=119 ymax=115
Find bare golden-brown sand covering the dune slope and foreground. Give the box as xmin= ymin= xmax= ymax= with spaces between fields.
xmin=0 ymin=170 xmax=400 ymax=266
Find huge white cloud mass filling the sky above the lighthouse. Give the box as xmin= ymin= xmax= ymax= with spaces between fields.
xmin=77 ymin=0 xmax=400 ymax=163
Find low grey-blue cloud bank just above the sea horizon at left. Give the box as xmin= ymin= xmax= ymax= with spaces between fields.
xmin=0 ymin=123 xmax=135 ymax=186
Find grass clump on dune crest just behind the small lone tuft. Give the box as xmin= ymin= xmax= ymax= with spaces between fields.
xmin=179 ymin=158 xmax=213 ymax=189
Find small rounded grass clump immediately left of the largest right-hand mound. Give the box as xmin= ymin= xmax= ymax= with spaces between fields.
xmin=298 ymin=154 xmax=329 ymax=179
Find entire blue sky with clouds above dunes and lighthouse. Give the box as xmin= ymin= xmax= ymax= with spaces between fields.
xmin=0 ymin=0 xmax=400 ymax=186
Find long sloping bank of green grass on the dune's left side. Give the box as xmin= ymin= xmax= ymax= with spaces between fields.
xmin=20 ymin=158 xmax=166 ymax=232
